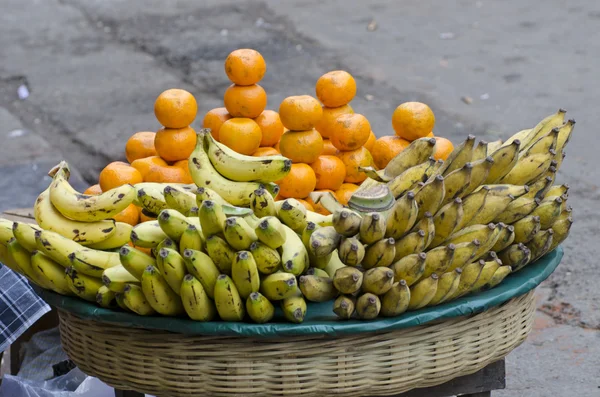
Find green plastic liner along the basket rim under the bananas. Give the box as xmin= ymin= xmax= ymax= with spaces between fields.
xmin=37 ymin=247 xmax=563 ymax=338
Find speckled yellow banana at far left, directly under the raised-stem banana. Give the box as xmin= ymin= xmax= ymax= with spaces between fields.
xmin=34 ymin=188 xmax=116 ymax=245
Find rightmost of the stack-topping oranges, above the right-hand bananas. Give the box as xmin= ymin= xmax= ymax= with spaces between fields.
xmin=392 ymin=102 xmax=435 ymax=141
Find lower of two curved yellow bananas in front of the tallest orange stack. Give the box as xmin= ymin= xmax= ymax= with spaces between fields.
xmin=189 ymin=129 xmax=279 ymax=206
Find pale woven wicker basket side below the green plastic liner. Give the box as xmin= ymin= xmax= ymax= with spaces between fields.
xmin=59 ymin=291 xmax=535 ymax=397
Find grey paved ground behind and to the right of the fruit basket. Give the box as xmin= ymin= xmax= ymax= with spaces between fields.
xmin=0 ymin=0 xmax=600 ymax=397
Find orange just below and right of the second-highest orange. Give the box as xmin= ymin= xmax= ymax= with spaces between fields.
xmin=329 ymin=114 xmax=371 ymax=151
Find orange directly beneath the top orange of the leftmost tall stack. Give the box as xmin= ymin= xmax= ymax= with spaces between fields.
xmin=154 ymin=127 xmax=196 ymax=161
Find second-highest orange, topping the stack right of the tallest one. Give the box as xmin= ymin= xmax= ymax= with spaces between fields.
xmin=315 ymin=70 xmax=356 ymax=108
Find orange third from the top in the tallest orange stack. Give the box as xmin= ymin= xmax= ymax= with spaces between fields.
xmin=219 ymin=117 xmax=262 ymax=156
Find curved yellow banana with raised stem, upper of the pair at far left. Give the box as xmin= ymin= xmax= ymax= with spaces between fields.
xmin=49 ymin=161 xmax=135 ymax=222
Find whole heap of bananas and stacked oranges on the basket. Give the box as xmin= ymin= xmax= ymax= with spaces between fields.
xmin=0 ymin=50 xmax=575 ymax=324
